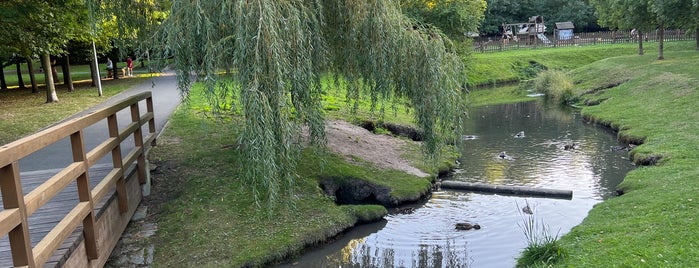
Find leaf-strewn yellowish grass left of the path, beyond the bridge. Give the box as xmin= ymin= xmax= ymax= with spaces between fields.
xmin=0 ymin=78 xmax=145 ymax=145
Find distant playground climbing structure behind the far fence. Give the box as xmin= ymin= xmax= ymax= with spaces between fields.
xmin=502 ymin=16 xmax=551 ymax=46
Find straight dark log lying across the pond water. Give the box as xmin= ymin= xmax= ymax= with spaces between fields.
xmin=440 ymin=181 xmax=573 ymax=200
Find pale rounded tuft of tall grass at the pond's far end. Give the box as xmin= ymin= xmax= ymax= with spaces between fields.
xmin=532 ymin=70 xmax=574 ymax=104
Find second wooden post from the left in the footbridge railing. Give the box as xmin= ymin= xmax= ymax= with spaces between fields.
xmin=70 ymin=130 xmax=99 ymax=260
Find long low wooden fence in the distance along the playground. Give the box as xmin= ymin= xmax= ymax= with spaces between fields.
xmin=473 ymin=30 xmax=695 ymax=52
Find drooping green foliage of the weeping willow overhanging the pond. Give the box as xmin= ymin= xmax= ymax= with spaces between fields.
xmin=162 ymin=0 xmax=465 ymax=203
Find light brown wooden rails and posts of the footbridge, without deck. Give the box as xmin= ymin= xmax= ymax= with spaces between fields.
xmin=0 ymin=92 xmax=155 ymax=267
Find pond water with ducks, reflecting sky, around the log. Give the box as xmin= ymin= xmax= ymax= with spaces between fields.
xmin=280 ymin=101 xmax=634 ymax=267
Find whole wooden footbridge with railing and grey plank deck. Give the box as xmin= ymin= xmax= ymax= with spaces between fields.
xmin=0 ymin=92 xmax=156 ymax=267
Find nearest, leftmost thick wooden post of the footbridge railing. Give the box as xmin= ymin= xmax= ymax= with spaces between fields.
xmin=0 ymin=162 xmax=35 ymax=267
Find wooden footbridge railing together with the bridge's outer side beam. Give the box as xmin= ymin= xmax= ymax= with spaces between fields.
xmin=0 ymin=92 xmax=155 ymax=267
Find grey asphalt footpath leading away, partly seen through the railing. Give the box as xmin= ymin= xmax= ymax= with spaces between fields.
xmin=19 ymin=71 xmax=181 ymax=172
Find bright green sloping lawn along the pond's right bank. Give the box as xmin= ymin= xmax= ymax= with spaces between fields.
xmin=561 ymin=50 xmax=699 ymax=267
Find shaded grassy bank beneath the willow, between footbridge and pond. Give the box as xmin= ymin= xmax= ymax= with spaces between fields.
xmin=150 ymin=82 xmax=448 ymax=267
